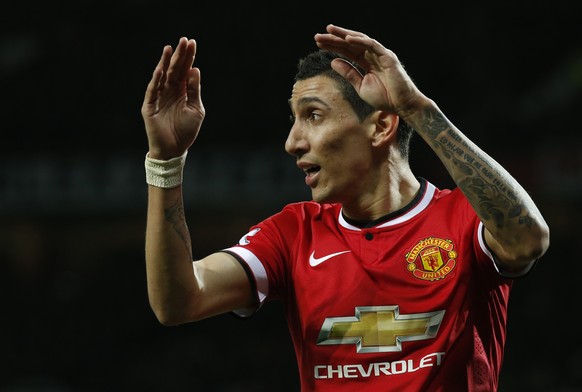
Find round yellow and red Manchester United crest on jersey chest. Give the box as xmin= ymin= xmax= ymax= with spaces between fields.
xmin=406 ymin=237 xmax=457 ymax=281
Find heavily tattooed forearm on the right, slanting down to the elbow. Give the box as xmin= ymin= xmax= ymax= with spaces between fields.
xmin=406 ymin=100 xmax=549 ymax=268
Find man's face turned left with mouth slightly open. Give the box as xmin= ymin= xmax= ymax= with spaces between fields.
xmin=285 ymin=76 xmax=375 ymax=203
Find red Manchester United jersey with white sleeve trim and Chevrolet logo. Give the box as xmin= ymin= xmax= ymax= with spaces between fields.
xmin=224 ymin=180 xmax=525 ymax=392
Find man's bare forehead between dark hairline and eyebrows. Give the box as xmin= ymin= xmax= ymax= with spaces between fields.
xmin=289 ymin=76 xmax=347 ymax=108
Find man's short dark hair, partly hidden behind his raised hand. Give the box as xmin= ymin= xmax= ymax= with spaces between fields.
xmin=295 ymin=49 xmax=414 ymax=158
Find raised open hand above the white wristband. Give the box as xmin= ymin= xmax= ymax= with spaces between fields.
xmin=141 ymin=37 xmax=206 ymax=159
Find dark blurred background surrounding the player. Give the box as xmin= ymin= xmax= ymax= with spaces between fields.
xmin=0 ymin=0 xmax=582 ymax=392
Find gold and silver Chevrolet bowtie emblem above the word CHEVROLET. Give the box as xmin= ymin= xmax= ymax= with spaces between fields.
xmin=317 ymin=305 xmax=445 ymax=353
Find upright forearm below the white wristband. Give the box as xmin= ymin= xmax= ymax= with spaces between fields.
xmin=145 ymin=186 xmax=196 ymax=325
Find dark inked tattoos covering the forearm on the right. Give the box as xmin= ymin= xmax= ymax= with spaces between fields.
xmin=420 ymin=109 xmax=533 ymax=228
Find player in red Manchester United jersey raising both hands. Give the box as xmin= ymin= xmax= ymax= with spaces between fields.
xmin=142 ymin=25 xmax=549 ymax=392
